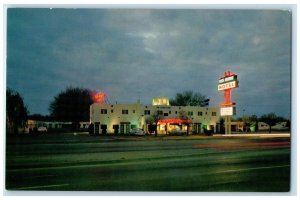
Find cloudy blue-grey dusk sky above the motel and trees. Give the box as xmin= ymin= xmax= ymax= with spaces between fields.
xmin=6 ymin=8 xmax=291 ymax=117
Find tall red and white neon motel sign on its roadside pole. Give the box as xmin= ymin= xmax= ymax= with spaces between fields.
xmin=218 ymin=71 xmax=239 ymax=135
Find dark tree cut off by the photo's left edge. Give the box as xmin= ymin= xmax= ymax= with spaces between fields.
xmin=6 ymin=89 xmax=28 ymax=133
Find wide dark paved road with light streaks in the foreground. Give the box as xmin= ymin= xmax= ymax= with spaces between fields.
xmin=6 ymin=135 xmax=290 ymax=192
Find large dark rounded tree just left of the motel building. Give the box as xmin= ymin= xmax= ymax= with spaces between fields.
xmin=49 ymin=87 xmax=93 ymax=129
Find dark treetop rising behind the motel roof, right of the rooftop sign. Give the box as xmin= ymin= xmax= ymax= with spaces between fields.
xmin=170 ymin=91 xmax=209 ymax=106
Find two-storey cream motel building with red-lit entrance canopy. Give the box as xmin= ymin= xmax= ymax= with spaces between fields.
xmin=90 ymin=97 xmax=220 ymax=135
